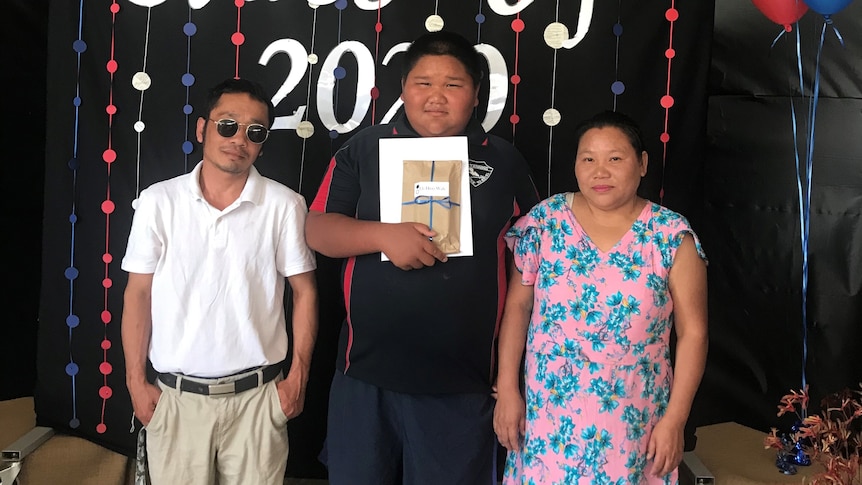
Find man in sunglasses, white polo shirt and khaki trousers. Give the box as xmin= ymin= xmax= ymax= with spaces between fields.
xmin=116 ymin=79 xmax=317 ymax=485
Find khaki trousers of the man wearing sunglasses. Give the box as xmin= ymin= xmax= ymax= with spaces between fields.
xmin=146 ymin=378 xmax=288 ymax=485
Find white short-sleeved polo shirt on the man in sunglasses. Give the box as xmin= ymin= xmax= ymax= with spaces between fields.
xmin=121 ymin=162 xmax=316 ymax=377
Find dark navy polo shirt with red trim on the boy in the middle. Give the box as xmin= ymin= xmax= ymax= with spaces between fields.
xmin=310 ymin=115 xmax=538 ymax=394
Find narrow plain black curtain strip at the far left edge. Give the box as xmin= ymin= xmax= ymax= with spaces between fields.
xmin=0 ymin=0 xmax=48 ymax=401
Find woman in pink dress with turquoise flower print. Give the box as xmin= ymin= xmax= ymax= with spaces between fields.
xmin=494 ymin=112 xmax=707 ymax=485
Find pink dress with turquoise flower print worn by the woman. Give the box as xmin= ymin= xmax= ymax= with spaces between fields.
xmin=503 ymin=194 xmax=706 ymax=485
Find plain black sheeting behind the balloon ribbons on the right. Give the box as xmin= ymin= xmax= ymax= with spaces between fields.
xmin=699 ymin=0 xmax=862 ymax=430
